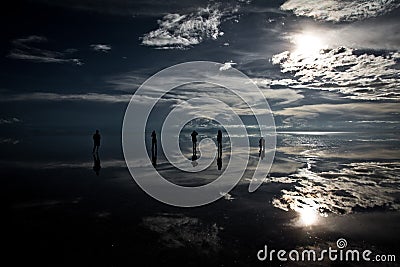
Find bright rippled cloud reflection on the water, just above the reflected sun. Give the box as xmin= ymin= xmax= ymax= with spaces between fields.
xmin=271 ymin=161 xmax=400 ymax=215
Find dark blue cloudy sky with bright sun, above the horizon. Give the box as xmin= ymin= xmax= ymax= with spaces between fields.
xmin=0 ymin=0 xmax=400 ymax=141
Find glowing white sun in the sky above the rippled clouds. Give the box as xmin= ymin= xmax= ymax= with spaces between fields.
xmin=293 ymin=34 xmax=326 ymax=56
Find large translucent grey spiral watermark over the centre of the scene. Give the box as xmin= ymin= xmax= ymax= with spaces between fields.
xmin=122 ymin=61 xmax=276 ymax=207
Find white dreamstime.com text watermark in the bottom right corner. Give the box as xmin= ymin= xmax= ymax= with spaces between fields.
xmin=257 ymin=238 xmax=396 ymax=262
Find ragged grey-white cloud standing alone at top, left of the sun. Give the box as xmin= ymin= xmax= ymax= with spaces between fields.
xmin=141 ymin=5 xmax=232 ymax=49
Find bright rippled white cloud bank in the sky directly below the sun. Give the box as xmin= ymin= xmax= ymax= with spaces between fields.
xmin=272 ymin=47 xmax=400 ymax=100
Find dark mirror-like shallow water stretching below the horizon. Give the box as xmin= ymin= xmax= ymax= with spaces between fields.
xmin=0 ymin=132 xmax=400 ymax=266
